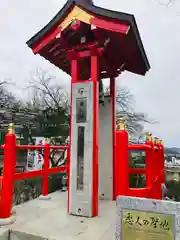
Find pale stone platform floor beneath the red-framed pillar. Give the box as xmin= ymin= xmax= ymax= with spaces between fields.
xmin=0 ymin=191 xmax=116 ymax=240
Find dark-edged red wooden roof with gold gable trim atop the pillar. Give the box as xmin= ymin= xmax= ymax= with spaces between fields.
xmin=27 ymin=0 xmax=150 ymax=78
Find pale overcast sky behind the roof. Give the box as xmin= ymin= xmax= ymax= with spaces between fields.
xmin=0 ymin=0 xmax=180 ymax=147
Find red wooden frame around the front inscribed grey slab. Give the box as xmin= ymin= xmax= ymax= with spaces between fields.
xmin=68 ymin=45 xmax=101 ymax=217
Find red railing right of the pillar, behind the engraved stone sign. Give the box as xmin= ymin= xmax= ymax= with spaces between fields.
xmin=115 ymin=129 xmax=165 ymax=199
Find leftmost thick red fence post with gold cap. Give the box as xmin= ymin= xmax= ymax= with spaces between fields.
xmin=0 ymin=124 xmax=16 ymax=218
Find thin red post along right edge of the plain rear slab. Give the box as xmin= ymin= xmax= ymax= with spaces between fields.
xmin=110 ymin=77 xmax=116 ymax=200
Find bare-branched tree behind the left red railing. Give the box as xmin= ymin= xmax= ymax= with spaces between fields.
xmin=24 ymin=69 xmax=69 ymax=167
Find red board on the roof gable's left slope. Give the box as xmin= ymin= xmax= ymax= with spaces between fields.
xmin=32 ymin=27 xmax=61 ymax=54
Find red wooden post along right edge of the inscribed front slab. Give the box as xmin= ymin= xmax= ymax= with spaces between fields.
xmin=91 ymin=51 xmax=99 ymax=217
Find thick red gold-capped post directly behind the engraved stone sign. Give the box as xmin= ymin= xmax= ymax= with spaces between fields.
xmin=115 ymin=119 xmax=129 ymax=197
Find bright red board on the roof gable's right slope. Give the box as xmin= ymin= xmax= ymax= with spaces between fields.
xmin=90 ymin=18 xmax=129 ymax=34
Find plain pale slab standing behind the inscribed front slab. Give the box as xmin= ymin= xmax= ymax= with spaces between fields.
xmin=99 ymin=97 xmax=113 ymax=200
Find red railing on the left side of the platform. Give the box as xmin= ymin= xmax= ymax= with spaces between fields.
xmin=0 ymin=133 xmax=70 ymax=218
